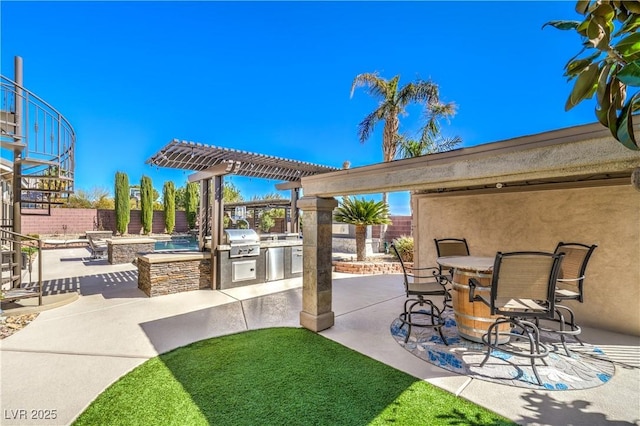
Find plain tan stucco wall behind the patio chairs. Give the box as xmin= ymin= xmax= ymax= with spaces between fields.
xmin=414 ymin=185 xmax=640 ymax=336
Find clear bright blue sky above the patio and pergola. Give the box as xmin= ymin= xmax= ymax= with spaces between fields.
xmin=0 ymin=1 xmax=595 ymax=214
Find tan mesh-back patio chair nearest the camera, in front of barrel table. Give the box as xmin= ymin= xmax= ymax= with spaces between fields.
xmin=469 ymin=251 xmax=564 ymax=385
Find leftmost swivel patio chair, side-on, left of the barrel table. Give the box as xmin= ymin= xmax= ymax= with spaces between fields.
xmin=391 ymin=243 xmax=448 ymax=345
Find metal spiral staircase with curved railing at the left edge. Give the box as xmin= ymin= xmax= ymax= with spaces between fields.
xmin=0 ymin=57 xmax=76 ymax=303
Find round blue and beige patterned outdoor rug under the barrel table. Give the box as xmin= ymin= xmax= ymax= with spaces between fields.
xmin=391 ymin=309 xmax=615 ymax=390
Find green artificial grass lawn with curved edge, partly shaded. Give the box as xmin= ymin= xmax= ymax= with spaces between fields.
xmin=74 ymin=328 xmax=515 ymax=426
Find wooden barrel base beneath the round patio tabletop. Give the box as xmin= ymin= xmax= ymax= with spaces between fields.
xmin=452 ymin=269 xmax=510 ymax=344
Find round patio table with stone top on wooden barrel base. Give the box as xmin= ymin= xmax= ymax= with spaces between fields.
xmin=437 ymin=256 xmax=509 ymax=344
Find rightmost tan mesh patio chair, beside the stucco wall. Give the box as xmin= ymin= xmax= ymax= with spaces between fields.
xmin=545 ymin=242 xmax=598 ymax=356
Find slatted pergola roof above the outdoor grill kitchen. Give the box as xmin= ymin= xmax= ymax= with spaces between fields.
xmin=146 ymin=139 xmax=339 ymax=182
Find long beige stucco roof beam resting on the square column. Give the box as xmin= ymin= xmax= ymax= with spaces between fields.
xmin=302 ymin=123 xmax=640 ymax=197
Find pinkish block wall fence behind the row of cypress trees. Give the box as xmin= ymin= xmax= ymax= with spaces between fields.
xmin=22 ymin=208 xmax=411 ymax=241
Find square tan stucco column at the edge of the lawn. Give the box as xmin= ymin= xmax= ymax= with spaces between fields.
xmin=297 ymin=197 xmax=338 ymax=331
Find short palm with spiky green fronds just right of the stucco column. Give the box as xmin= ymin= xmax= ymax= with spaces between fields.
xmin=333 ymin=197 xmax=391 ymax=261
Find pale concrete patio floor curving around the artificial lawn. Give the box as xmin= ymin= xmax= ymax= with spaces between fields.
xmin=0 ymin=248 xmax=640 ymax=425
